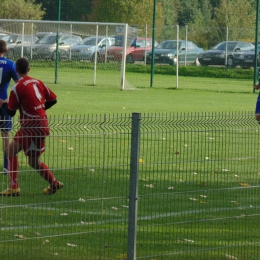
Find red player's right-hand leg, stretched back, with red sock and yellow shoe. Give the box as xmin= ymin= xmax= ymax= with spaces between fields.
xmin=26 ymin=138 xmax=63 ymax=195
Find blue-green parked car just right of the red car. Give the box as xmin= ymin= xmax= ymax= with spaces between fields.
xmin=146 ymin=40 xmax=203 ymax=65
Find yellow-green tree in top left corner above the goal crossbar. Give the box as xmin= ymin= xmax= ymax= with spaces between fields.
xmin=0 ymin=0 xmax=45 ymax=20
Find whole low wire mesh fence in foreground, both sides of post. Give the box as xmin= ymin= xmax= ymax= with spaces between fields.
xmin=0 ymin=112 xmax=260 ymax=260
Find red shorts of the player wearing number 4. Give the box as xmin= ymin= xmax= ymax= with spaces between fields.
xmin=14 ymin=129 xmax=45 ymax=156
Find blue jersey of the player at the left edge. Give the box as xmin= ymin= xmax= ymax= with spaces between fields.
xmin=0 ymin=57 xmax=18 ymax=99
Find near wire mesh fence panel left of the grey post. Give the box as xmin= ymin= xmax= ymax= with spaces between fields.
xmin=0 ymin=115 xmax=131 ymax=259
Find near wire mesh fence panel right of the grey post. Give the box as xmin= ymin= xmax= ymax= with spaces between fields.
xmin=137 ymin=113 xmax=259 ymax=259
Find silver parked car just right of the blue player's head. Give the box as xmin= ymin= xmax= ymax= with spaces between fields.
xmin=1 ymin=34 xmax=38 ymax=59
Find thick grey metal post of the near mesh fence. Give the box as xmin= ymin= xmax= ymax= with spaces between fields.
xmin=127 ymin=113 xmax=141 ymax=260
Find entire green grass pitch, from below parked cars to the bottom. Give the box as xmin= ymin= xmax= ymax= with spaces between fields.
xmin=0 ymin=63 xmax=260 ymax=260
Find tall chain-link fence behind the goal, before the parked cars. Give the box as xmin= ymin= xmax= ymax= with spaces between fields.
xmin=0 ymin=19 xmax=254 ymax=93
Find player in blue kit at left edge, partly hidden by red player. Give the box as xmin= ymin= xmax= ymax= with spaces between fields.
xmin=0 ymin=40 xmax=18 ymax=173
